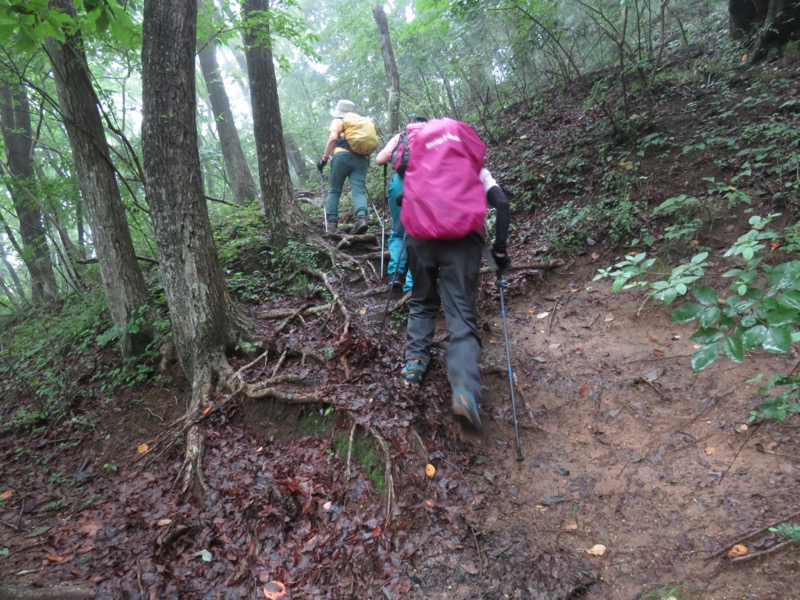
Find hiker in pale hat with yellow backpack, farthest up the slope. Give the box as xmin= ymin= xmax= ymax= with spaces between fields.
xmin=317 ymin=100 xmax=378 ymax=235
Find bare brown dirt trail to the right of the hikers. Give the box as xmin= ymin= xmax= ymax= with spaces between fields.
xmin=400 ymin=254 xmax=798 ymax=600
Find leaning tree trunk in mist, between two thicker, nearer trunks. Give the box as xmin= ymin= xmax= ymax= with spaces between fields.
xmin=199 ymin=9 xmax=260 ymax=209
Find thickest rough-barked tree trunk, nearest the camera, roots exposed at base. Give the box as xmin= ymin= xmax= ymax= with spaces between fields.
xmin=142 ymin=0 xmax=241 ymax=380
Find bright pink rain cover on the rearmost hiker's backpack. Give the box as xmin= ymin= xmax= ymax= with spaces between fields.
xmin=400 ymin=119 xmax=486 ymax=240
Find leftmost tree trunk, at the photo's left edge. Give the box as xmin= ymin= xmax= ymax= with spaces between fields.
xmin=0 ymin=81 xmax=58 ymax=303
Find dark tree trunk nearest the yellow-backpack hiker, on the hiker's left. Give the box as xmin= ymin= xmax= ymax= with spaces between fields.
xmin=242 ymin=0 xmax=305 ymax=245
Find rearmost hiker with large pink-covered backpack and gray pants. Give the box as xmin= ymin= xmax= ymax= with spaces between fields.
xmin=400 ymin=118 xmax=510 ymax=430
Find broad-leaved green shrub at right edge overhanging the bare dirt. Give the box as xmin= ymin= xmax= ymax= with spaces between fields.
xmin=595 ymin=214 xmax=800 ymax=421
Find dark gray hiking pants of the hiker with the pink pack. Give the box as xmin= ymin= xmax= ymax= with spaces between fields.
xmin=406 ymin=234 xmax=483 ymax=402
